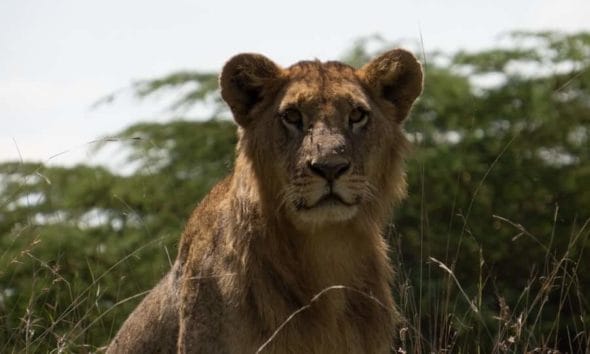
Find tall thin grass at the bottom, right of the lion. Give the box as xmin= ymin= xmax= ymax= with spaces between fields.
xmin=394 ymin=212 xmax=590 ymax=353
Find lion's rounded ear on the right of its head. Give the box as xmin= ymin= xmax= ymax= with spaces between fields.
xmin=358 ymin=49 xmax=422 ymax=122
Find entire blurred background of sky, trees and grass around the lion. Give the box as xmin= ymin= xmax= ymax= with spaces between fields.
xmin=0 ymin=0 xmax=590 ymax=353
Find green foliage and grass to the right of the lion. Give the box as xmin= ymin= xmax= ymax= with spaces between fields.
xmin=396 ymin=33 xmax=590 ymax=352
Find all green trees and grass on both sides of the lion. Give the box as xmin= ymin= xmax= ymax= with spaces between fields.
xmin=0 ymin=32 xmax=590 ymax=353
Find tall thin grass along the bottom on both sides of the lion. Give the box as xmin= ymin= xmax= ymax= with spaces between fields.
xmin=0 ymin=210 xmax=590 ymax=353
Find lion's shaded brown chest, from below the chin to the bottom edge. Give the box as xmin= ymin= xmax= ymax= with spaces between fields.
xmin=206 ymin=210 xmax=392 ymax=354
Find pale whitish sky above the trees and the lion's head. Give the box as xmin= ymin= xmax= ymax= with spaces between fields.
xmin=0 ymin=0 xmax=590 ymax=165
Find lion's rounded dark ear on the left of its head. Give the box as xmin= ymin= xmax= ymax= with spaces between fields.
xmin=219 ymin=53 xmax=281 ymax=125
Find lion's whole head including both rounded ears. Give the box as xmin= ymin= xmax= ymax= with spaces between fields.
xmin=220 ymin=49 xmax=422 ymax=225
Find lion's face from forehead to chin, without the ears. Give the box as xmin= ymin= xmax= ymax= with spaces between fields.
xmin=266 ymin=63 xmax=391 ymax=224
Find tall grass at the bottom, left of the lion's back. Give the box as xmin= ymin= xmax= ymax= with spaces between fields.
xmin=0 ymin=225 xmax=172 ymax=353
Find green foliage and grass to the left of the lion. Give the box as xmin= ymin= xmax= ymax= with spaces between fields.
xmin=0 ymin=121 xmax=236 ymax=352
